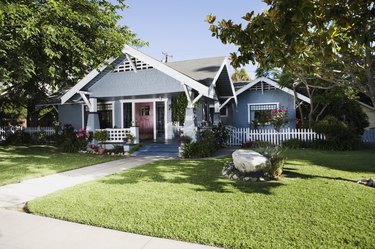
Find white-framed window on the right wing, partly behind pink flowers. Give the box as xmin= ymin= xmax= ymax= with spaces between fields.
xmin=248 ymin=103 xmax=278 ymax=125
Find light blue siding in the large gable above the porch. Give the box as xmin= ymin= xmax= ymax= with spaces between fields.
xmin=88 ymin=69 xmax=183 ymax=98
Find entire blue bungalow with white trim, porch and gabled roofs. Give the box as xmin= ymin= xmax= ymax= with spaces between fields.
xmin=57 ymin=46 xmax=309 ymax=142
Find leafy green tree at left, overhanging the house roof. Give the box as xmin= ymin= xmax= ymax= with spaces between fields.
xmin=0 ymin=0 xmax=143 ymax=123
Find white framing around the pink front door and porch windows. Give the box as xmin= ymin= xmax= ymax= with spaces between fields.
xmin=120 ymin=98 xmax=168 ymax=140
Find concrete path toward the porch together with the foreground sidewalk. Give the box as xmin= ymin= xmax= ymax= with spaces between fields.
xmin=0 ymin=156 xmax=220 ymax=249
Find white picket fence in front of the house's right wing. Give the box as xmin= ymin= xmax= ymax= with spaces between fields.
xmin=228 ymin=127 xmax=324 ymax=146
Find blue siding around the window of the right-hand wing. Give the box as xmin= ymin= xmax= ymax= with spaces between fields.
xmin=232 ymin=89 xmax=296 ymax=128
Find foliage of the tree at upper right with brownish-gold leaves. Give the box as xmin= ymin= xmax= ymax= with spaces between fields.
xmin=207 ymin=0 xmax=375 ymax=108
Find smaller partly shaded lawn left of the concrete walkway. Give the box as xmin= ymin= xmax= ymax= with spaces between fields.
xmin=0 ymin=146 xmax=118 ymax=186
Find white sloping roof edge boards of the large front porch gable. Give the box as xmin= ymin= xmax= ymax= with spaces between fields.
xmin=61 ymin=45 xmax=215 ymax=104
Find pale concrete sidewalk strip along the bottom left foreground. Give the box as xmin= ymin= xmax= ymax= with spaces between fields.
xmin=0 ymin=209 xmax=219 ymax=249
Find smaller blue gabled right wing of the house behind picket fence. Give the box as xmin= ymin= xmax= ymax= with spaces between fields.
xmin=226 ymin=77 xmax=310 ymax=129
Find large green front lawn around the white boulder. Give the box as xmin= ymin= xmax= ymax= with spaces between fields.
xmin=28 ymin=150 xmax=375 ymax=248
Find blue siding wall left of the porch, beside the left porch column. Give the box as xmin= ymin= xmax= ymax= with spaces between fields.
xmin=58 ymin=104 xmax=82 ymax=130
